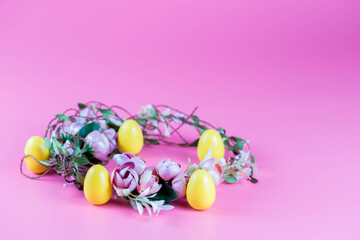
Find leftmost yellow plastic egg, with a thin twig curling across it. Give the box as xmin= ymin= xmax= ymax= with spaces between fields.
xmin=24 ymin=136 xmax=50 ymax=174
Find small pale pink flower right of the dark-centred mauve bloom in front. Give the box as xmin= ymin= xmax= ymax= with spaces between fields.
xmin=137 ymin=167 xmax=161 ymax=195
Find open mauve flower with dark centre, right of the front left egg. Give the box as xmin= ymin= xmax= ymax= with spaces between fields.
xmin=111 ymin=162 xmax=139 ymax=197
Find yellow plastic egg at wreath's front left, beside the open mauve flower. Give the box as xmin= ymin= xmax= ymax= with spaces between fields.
xmin=84 ymin=165 xmax=112 ymax=205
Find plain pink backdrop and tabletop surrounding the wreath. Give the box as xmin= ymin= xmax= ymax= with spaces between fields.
xmin=0 ymin=0 xmax=360 ymax=239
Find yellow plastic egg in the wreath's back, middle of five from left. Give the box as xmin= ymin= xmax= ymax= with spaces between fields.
xmin=117 ymin=119 xmax=144 ymax=154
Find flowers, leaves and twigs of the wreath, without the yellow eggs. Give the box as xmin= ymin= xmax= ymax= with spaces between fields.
xmin=20 ymin=102 xmax=257 ymax=215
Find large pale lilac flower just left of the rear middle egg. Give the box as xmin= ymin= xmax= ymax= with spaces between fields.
xmin=85 ymin=128 xmax=116 ymax=161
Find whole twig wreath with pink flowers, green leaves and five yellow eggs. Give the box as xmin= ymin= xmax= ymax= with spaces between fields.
xmin=20 ymin=101 xmax=257 ymax=215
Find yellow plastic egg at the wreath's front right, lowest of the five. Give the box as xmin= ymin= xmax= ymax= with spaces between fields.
xmin=186 ymin=169 xmax=216 ymax=210
